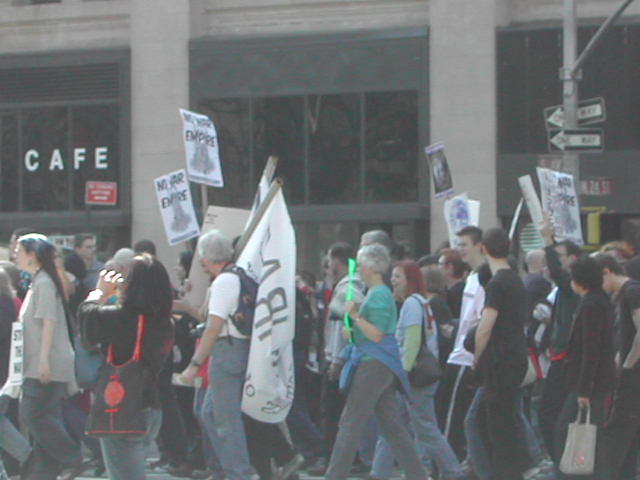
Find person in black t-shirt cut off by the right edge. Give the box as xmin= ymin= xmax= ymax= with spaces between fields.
xmin=596 ymin=254 xmax=640 ymax=480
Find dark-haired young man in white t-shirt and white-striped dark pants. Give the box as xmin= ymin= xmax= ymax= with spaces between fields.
xmin=442 ymin=227 xmax=484 ymax=460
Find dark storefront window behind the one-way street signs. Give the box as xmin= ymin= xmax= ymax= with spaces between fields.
xmin=498 ymin=25 xmax=640 ymax=154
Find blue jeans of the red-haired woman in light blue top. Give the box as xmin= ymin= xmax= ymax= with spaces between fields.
xmin=371 ymin=383 xmax=462 ymax=480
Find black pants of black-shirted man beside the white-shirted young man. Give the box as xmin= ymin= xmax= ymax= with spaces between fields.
xmin=478 ymin=388 xmax=530 ymax=480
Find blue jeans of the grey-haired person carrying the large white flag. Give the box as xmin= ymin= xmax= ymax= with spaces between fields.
xmin=203 ymin=338 xmax=253 ymax=480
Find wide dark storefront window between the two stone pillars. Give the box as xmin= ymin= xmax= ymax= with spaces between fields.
xmin=198 ymin=91 xmax=419 ymax=206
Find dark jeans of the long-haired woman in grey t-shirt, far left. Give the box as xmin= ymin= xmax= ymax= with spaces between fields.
xmin=20 ymin=378 xmax=82 ymax=480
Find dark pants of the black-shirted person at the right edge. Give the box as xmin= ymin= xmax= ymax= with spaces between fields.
xmin=604 ymin=368 xmax=640 ymax=480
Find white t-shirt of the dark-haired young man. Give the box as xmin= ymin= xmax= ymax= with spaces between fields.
xmin=447 ymin=272 xmax=484 ymax=367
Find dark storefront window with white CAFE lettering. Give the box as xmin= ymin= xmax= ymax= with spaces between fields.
xmin=0 ymin=104 xmax=120 ymax=212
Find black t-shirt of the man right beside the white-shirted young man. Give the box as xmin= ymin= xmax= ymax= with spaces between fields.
xmin=485 ymin=269 xmax=527 ymax=366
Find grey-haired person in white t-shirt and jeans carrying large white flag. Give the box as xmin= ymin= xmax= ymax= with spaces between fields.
xmin=183 ymin=230 xmax=253 ymax=480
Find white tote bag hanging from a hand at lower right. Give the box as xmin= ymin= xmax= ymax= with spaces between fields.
xmin=560 ymin=407 xmax=598 ymax=475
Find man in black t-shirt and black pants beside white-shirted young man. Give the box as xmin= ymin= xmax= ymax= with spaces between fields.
xmin=474 ymin=228 xmax=529 ymax=480
